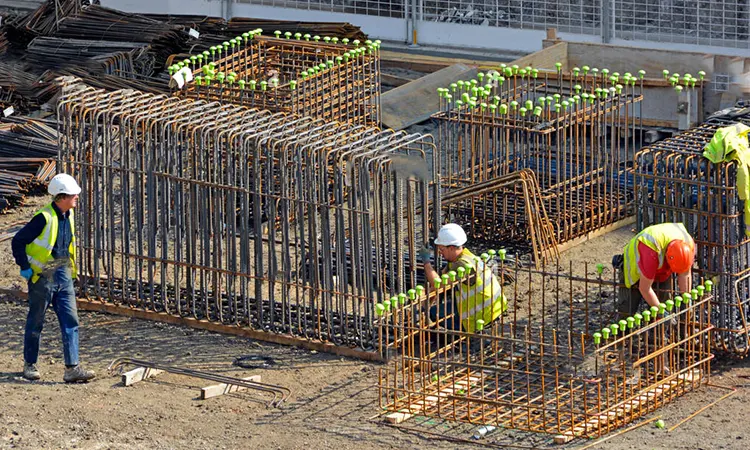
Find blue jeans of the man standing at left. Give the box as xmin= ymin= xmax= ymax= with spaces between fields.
xmin=23 ymin=267 xmax=78 ymax=366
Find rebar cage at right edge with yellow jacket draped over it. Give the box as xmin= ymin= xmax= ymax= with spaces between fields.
xmin=635 ymin=111 xmax=750 ymax=357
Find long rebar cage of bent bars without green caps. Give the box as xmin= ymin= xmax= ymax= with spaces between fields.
xmin=58 ymin=84 xmax=435 ymax=351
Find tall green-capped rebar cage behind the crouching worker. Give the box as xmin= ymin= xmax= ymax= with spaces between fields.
xmin=433 ymin=66 xmax=643 ymax=250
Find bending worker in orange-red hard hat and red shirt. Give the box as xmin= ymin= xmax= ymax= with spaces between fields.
xmin=612 ymin=223 xmax=695 ymax=316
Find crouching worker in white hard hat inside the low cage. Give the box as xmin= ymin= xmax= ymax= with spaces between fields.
xmin=419 ymin=223 xmax=508 ymax=332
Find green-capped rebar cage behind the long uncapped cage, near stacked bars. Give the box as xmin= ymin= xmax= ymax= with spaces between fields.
xmin=170 ymin=30 xmax=380 ymax=127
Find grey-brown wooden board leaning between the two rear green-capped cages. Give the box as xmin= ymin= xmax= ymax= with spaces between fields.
xmin=380 ymin=64 xmax=477 ymax=130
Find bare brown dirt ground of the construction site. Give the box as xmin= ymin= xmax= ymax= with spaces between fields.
xmin=0 ymin=198 xmax=750 ymax=450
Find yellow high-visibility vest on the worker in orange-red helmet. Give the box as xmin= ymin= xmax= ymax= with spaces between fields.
xmin=623 ymin=223 xmax=695 ymax=287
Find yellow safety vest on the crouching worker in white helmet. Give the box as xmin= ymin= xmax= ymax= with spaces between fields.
xmin=448 ymin=248 xmax=508 ymax=333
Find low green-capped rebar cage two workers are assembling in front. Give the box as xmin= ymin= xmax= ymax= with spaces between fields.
xmin=378 ymin=255 xmax=713 ymax=441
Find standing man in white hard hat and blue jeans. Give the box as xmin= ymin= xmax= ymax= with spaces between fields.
xmin=11 ymin=174 xmax=94 ymax=383
